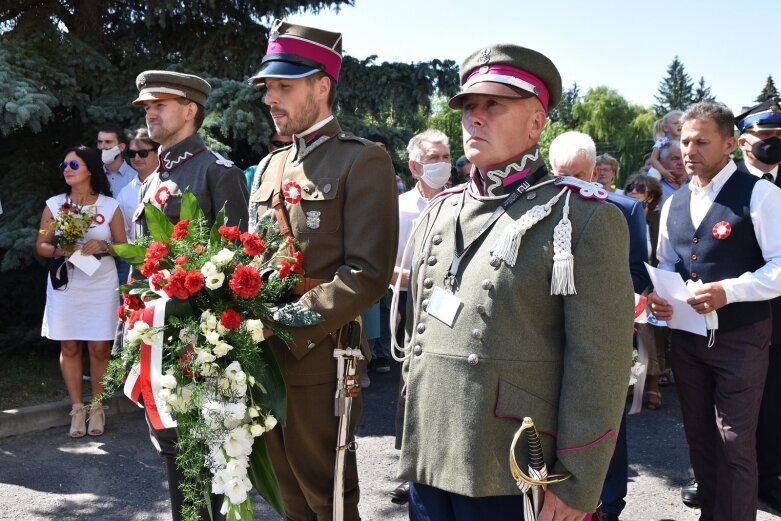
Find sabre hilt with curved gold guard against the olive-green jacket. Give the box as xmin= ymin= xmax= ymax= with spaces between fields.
xmin=510 ymin=416 xmax=570 ymax=521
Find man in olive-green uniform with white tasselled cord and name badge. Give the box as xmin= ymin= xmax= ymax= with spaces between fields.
xmin=399 ymin=44 xmax=634 ymax=521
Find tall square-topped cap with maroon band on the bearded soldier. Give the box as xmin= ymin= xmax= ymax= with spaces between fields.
xmin=247 ymin=20 xmax=342 ymax=85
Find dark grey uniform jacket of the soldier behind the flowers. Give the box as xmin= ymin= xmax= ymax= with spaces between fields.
xmin=133 ymin=134 xmax=249 ymax=237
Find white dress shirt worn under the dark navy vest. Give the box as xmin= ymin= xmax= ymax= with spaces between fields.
xmin=656 ymin=161 xmax=781 ymax=304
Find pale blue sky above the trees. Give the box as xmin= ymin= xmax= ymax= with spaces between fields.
xmin=288 ymin=0 xmax=781 ymax=113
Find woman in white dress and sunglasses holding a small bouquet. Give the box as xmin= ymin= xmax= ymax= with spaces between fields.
xmin=36 ymin=146 xmax=127 ymax=438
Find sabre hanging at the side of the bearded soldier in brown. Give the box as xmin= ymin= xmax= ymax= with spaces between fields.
xmin=333 ymin=320 xmax=363 ymax=521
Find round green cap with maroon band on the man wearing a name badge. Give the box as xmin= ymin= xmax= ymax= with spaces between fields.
xmin=449 ymin=43 xmax=561 ymax=112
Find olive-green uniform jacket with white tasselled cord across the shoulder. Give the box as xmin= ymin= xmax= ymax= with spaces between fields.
xmin=399 ymin=176 xmax=634 ymax=512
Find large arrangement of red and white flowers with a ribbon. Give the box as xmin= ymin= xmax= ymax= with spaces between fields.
xmin=106 ymin=192 xmax=321 ymax=520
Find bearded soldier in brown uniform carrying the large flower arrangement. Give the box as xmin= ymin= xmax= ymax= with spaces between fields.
xmin=249 ymin=21 xmax=398 ymax=520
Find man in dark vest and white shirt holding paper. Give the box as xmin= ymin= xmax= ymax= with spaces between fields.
xmin=649 ymin=102 xmax=781 ymax=521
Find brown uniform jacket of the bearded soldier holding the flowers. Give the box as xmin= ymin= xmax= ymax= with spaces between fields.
xmin=250 ymin=120 xmax=399 ymax=385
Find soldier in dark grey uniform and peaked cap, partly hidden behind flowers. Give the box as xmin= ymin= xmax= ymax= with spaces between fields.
xmin=133 ymin=71 xmax=248 ymax=521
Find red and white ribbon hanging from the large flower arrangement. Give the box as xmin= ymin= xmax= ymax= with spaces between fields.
xmin=124 ymin=299 xmax=176 ymax=430
